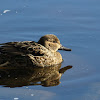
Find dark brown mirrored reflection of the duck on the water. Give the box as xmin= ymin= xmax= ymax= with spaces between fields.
xmin=0 ymin=64 xmax=72 ymax=87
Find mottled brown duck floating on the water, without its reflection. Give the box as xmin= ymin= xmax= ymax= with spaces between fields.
xmin=0 ymin=34 xmax=71 ymax=67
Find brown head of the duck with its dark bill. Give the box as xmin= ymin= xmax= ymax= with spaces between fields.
xmin=38 ymin=34 xmax=71 ymax=52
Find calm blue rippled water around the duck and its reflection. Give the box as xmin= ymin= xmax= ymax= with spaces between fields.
xmin=0 ymin=0 xmax=100 ymax=100
